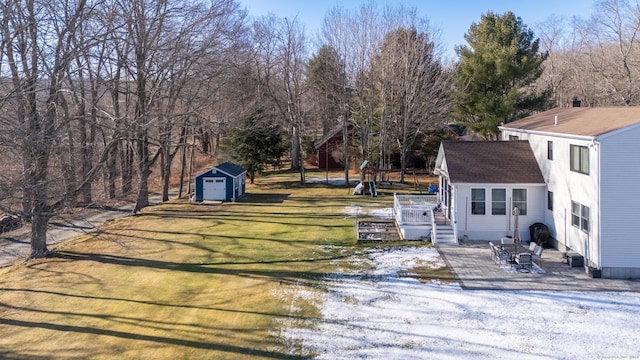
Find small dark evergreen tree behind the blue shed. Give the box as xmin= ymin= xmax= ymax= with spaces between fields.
xmin=225 ymin=109 xmax=287 ymax=184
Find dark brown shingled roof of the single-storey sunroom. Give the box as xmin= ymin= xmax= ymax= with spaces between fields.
xmin=442 ymin=140 xmax=544 ymax=184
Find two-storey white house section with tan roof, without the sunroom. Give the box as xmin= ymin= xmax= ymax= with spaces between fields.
xmin=500 ymin=107 xmax=640 ymax=278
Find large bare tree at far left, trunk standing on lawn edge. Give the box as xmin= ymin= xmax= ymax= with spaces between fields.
xmin=0 ymin=0 xmax=117 ymax=257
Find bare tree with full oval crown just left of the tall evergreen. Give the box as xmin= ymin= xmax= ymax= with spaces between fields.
xmin=374 ymin=8 xmax=451 ymax=182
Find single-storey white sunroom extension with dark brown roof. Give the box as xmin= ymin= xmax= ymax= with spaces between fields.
xmin=435 ymin=141 xmax=546 ymax=241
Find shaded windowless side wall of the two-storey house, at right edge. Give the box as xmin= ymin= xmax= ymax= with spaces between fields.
xmin=600 ymin=128 xmax=640 ymax=270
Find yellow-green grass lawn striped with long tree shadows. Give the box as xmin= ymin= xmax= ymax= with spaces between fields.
xmin=0 ymin=173 xmax=449 ymax=359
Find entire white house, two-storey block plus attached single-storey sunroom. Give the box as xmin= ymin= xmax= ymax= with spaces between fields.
xmin=435 ymin=107 xmax=640 ymax=279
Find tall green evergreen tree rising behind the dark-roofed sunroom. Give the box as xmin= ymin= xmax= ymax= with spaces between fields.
xmin=453 ymin=12 xmax=549 ymax=137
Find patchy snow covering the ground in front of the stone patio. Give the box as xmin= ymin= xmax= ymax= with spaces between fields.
xmin=277 ymin=247 xmax=640 ymax=359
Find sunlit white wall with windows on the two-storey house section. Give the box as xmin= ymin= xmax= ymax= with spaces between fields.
xmin=503 ymin=130 xmax=600 ymax=267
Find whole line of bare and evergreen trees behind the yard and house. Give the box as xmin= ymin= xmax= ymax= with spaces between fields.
xmin=0 ymin=0 xmax=640 ymax=257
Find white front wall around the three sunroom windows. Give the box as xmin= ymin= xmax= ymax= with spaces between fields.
xmin=452 ymin=183 xmax=546 ymax=242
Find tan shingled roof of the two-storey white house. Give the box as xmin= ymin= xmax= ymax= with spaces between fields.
xmin=500 ymin=106 xmax=640 ymax=137
